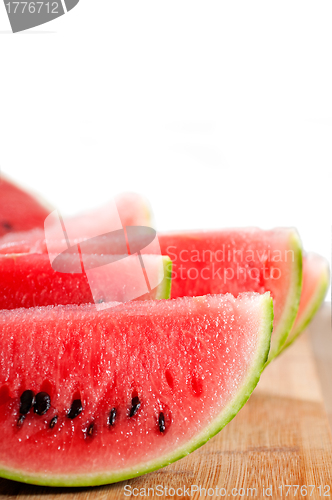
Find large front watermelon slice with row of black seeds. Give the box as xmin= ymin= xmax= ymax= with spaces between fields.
xmin=0 ymin=293 xmax=273 ymax=486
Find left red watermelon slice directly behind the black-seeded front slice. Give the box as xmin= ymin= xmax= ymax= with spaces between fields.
xmin=0 ymin=254 xmax=172 ymax=309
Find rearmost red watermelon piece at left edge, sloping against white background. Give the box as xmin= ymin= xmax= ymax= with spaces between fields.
xmin=0 ymin=175 xmax=51 ymax=236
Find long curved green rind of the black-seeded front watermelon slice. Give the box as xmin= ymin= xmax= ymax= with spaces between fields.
xmin=0 ymin=292 xmax=273 ymax=487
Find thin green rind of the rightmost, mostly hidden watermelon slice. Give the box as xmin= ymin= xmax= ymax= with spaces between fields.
xmin=279 ymin=265 xmax=330 ymax=354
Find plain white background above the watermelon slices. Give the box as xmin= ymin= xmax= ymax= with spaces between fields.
xmin=0 ymin=0 xmax=332 ymax=292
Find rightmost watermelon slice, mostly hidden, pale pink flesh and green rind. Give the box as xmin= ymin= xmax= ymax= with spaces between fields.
xmin=282 ymin=253 xmax=330 ymax=350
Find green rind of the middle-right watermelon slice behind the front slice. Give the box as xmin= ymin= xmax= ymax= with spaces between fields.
xmin=267 ymin=230 xmax=302 ymax=364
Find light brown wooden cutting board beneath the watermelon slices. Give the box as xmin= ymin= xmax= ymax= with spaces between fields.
xmin=0 ymin=305 xmax=332 ymax=500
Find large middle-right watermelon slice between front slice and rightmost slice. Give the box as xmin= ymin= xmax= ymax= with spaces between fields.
xmin=159 ymin=228 xmax=302 ymax=360
